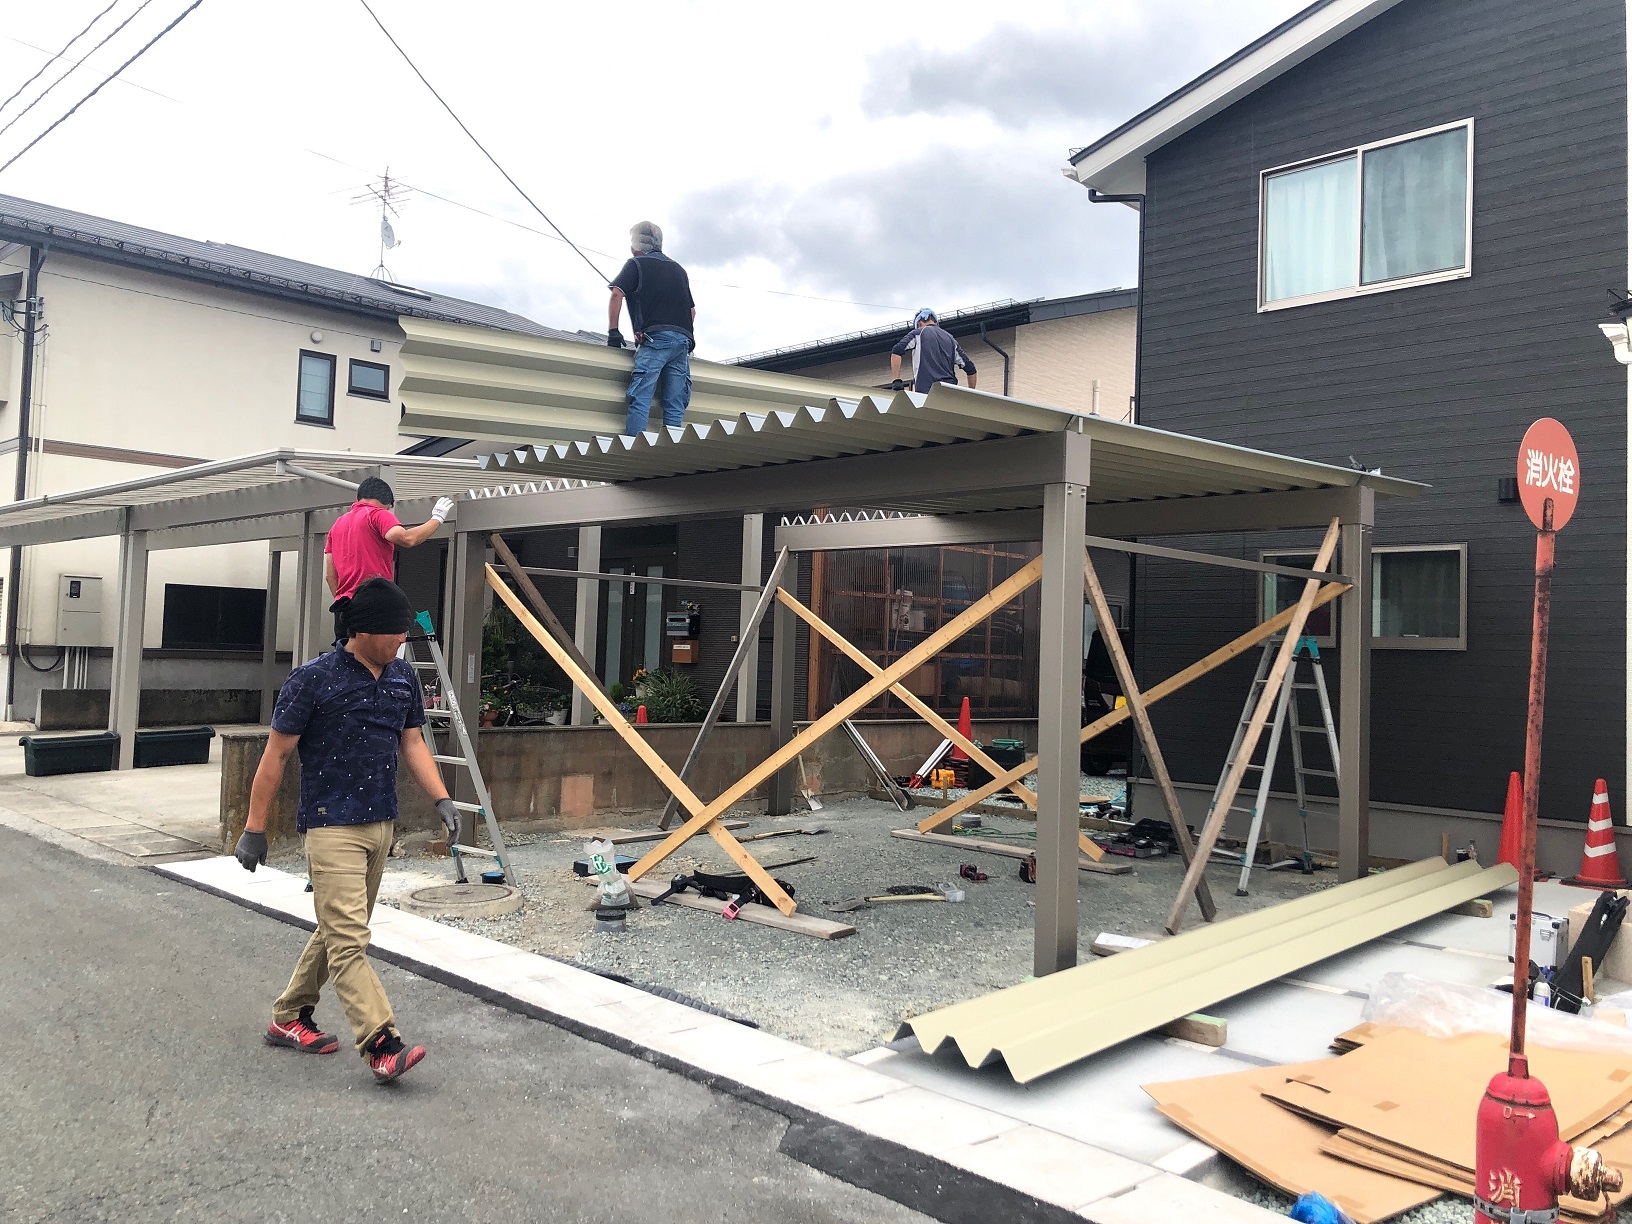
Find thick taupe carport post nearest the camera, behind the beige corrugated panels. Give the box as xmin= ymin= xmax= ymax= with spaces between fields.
xmin=1031 ymin=485 xmax=1087 ymax=978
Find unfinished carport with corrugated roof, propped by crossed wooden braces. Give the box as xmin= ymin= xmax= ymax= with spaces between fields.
xmin=440 ymin=383 xmax=1423 ymax=974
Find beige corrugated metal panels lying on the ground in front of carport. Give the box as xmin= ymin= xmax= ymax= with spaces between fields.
xmin=898 ymin=858 xmax=1518 ymax=1084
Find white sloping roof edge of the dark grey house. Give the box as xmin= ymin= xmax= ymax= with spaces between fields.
xmin=1066 ymin=0 xmax=1400 ymax=196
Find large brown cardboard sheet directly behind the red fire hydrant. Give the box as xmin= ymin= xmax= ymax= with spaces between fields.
xmin=1266 ymin=1030 xmax=1632 ymax=1172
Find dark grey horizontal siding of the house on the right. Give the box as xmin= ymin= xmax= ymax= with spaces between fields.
xmin=1138 ymin=0 xmax=1627 ymax=819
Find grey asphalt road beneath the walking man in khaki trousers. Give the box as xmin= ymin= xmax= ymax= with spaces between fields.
xmin=0 ymin=827 xmax=927 ymax=1224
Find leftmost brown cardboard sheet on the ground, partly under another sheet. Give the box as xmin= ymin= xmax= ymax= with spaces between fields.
xmin=1144 ymin=1062 xmax=1439 ymax=1224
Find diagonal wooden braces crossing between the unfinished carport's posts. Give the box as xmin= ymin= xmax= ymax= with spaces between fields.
xmin=486 ymin=519 xmax=1348 ymax=934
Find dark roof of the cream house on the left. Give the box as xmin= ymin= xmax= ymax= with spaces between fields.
xmin=0 ymin=196 xmax=589 ymax=341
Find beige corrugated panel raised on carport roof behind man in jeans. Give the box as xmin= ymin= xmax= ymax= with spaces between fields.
xmin=398 ymin=318 xmax=867 ymax=442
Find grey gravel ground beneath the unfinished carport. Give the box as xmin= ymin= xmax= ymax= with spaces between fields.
xmin=276 ymin=790 xmax=1335 ymax=1056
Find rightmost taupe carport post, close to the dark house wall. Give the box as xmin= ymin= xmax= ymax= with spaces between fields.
xmin=1337 ymin=488 xmax=1374 ymax=881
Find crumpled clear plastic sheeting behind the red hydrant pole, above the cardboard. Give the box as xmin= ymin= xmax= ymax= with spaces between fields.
xmin=1361 ymin=973 xmax=1632 ymax=1051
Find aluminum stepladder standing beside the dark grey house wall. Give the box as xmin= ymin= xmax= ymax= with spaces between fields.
xmin=1208 ymin=636 xmax=1342 ymax=896
